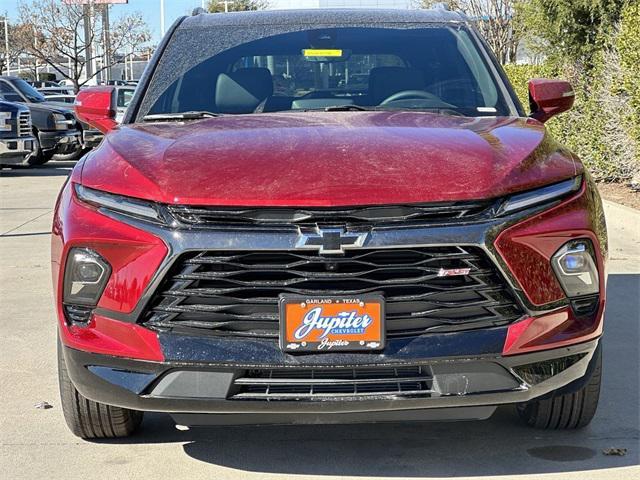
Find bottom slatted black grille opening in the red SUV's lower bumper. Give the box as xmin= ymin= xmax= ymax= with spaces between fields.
xmin=230 ymin=366 xmax=434 ymax=400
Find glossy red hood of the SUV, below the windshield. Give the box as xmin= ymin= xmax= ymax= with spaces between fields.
xmin=81 ymin=112 xmax=582 ymax=207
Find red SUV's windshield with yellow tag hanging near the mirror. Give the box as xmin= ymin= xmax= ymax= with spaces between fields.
xmin=138 ymin=24 xmax=516 ymax=118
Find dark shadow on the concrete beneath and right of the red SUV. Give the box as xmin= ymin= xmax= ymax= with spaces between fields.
xmin=102 ymin=275 xmax=640 ymax=477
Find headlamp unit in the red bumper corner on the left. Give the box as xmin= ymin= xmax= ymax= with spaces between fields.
xmin=63 ymin=248 xmax=111 ymax=306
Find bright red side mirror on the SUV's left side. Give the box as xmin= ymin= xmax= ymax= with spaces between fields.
xmin=75 ymin=86 xmax=118 ymax=133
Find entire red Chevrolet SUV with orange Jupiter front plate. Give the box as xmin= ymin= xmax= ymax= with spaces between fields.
xmin=52 ymin=10 xmax=607 ymax=438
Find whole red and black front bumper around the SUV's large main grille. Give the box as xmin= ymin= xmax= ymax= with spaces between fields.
xmin=52 ymin=178 xmax=606 ymax=424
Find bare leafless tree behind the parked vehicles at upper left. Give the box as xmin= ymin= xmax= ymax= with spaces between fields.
xmin=16 ymin=0 xmax=150 ymax=92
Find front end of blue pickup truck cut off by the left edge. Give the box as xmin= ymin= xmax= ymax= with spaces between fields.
xmin=0 ymin=101 xmax=33 ymax=166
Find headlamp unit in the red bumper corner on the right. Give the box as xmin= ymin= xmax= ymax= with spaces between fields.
xmin=551 ymin=239 xmax=600 ymax=297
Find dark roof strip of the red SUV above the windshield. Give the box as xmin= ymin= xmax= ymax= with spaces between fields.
xmin=178 ymin=8 xmax=467 ymax=29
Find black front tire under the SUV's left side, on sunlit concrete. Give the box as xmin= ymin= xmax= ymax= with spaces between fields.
xmin=58 ymin=341 xmax=143 ymax=439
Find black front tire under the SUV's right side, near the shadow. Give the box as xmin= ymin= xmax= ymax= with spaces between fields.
xmin=517 ymin=348 xmax=602 ymax=430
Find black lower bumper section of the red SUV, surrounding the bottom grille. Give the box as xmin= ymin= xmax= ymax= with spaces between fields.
xmin=64 ymin=340 xmax=598 ymax=424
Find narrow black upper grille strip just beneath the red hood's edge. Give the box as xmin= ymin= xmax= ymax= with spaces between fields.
xmin=167 ymin=201 xmax=494 ymax=228
